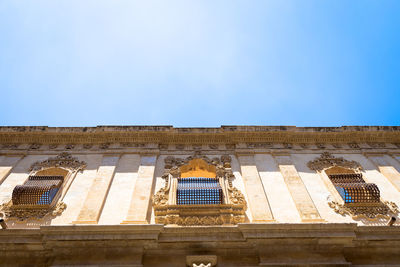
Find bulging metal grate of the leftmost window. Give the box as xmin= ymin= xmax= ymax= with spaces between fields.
xmin=12 ymin=176 xmax=64 ymax=205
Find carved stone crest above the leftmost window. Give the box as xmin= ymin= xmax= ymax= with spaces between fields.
xmin=29 ymin=152 xmax=86 ymax=172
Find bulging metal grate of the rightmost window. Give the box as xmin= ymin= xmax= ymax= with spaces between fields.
xmin=328 ymin=173 xmax=380 ymax=203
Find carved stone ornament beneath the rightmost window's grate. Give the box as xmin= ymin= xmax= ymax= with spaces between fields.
xmin=328 ymin=201 xmax=399 ymax=220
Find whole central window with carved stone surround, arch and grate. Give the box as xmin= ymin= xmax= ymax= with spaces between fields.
xmin=153 ymin=154 xmax=247 ymax=226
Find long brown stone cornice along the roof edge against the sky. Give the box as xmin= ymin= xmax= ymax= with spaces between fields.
xmin=0 ymin=126 xmax=400 ymax=145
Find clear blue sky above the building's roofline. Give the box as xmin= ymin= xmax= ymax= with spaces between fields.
xmin=0 ymin=0 xmax=400 ymax=127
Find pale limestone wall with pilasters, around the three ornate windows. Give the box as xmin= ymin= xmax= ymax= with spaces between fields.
xmin=0 ymin=143 xmax=400 ymax=228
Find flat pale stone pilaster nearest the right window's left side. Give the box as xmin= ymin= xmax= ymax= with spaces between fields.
xmin=274 ymin=155 xmax=324 ymax=222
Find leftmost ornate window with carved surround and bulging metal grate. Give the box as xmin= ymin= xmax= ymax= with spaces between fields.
xmin=0 ymin=153 xmax=86 ymax=221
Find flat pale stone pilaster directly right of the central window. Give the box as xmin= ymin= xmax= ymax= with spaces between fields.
xmin=237 ymin=154 xmax=274 ymax=222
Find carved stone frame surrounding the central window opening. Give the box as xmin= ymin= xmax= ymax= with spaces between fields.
xmin=153 ymin=152 xmax=247 ymax=226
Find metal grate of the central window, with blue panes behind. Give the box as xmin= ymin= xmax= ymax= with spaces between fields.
xmin=177 ymin=177 xmax=222 ymax=205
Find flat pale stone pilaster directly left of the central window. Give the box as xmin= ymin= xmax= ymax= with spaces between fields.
xmin=122 ymin=155 xmax=157 ymax=224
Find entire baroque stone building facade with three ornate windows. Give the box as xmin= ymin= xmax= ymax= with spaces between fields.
xmin=0 ymin=126 xmax=400 ymax=267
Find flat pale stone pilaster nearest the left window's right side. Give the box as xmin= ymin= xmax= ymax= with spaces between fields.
xmin=73 ymin=155 xmax=119 ymax=224
